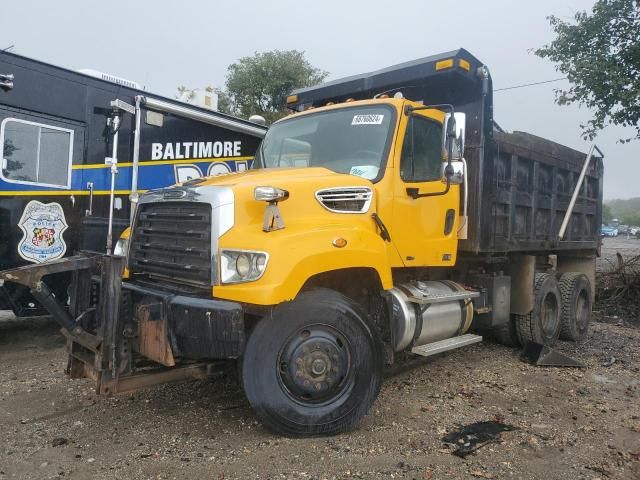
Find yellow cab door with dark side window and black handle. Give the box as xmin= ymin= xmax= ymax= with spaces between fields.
xmin=391 ymin=110 xmax=460 ymax=267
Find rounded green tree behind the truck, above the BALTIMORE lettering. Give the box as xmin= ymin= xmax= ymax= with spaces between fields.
xmin=225 ymin=50 xmax=328 ymax=123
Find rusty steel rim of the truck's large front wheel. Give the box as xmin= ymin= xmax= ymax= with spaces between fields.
xmin=277 ymin=325 xmax=353 ymax=404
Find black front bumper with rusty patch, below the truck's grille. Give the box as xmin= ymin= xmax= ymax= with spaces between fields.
xmin=122 ymin=282 xmax=246 ymax=365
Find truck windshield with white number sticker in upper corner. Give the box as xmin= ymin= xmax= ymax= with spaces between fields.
xmin=254 ymin=105 xmax=394 ymax=180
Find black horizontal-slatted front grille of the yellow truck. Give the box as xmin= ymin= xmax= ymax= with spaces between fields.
xmin=129 ymin=202 xmax=212 ymax=286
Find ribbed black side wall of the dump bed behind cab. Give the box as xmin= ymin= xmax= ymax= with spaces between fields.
xmin=480 ymin=131 xmax=603 ymax=252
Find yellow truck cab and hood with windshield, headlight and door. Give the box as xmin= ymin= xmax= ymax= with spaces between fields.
xmin=136 ymin=99 xmax=460 ymax=305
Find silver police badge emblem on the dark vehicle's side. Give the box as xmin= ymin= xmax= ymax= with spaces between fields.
xmin=18 ymin=200 xmax=68 ymax=263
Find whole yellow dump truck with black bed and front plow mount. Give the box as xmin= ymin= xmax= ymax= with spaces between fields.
xmin=3 ymin=50 xmax=603 ymax=436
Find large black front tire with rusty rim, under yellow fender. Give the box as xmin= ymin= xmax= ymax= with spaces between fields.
xmin=242 ymin=290 xmax=383 ymax=437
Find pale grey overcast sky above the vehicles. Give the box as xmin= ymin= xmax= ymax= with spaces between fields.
xmin=0 ymin=0 xmax=640 ymax=199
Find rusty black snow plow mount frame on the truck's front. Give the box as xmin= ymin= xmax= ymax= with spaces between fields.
xmin=0 ymin=252 xmax=221 ymax=395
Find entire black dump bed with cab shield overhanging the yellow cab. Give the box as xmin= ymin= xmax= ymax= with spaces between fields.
xmin=289 ymin=49 xmax=603 ymax=253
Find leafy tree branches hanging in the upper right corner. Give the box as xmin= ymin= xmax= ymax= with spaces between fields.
xmin=535 ymin=0 xmax=640 ymax=142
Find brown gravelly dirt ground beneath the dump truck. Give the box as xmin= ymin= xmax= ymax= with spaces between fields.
xmin=0 ymin=239 xmax=640 ymax=480
